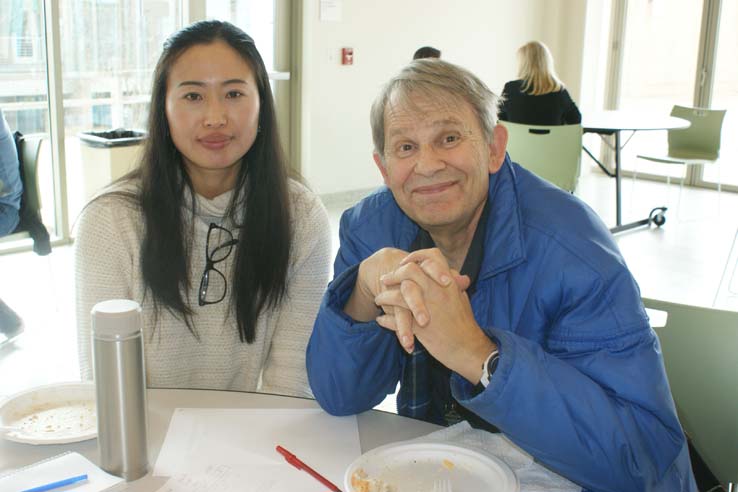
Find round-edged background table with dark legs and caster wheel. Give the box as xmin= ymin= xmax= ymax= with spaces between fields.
xmin=582 ymin=110 xmax=690 ymax=234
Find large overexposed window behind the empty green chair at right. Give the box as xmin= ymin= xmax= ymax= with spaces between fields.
xmin=586 ymin=0 xmax=738 ymax=191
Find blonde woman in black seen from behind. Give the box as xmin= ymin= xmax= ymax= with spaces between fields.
xmin=499 ymin=41 xmax=582 ymax=125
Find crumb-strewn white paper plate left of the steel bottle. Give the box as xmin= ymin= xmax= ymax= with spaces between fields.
xmin=0 ymin=382 xmax=97 ymax=444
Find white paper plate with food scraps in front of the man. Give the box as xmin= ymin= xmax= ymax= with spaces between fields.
xmin=344 ymin=443 xmax=520 ymax=492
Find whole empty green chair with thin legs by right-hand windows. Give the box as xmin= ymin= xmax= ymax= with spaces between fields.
xmin=638 ymin=106 xmax=725 ymax=217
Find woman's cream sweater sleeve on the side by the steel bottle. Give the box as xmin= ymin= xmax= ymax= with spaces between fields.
xmin=74 ymin=196 xmax=140 ymax=380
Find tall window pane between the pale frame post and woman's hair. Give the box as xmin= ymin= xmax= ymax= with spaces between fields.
xmin=59 ymin=0 xmax=181 ymax=224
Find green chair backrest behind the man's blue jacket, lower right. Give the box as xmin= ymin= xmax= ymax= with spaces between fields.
xmin=643 ymin=299 xmax=738 ymax=484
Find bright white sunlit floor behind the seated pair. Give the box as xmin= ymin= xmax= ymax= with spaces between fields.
xmin=0 ymin=163 xmax=738 ymax=397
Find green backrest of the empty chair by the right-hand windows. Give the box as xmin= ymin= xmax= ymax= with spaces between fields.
xmin=669 ymin=106 xmax=725 ymax=160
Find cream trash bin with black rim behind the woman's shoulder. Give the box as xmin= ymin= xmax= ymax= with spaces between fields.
xmin=78 ymin=128 xmax=146 ymax=201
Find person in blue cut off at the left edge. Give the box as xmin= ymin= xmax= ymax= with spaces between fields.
xmin=0 ymin=109 xmax=23 ymax=345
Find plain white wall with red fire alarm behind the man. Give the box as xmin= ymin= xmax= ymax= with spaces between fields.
xmin=301 ymin=0 xmax=586 ymax=194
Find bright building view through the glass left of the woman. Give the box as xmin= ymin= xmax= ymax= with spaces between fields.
xmin=0 ymin=0 xmax=181 ymax=228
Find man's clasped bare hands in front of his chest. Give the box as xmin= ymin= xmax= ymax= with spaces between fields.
xmin=344 ymin=248 xmax=495 ymax=384
